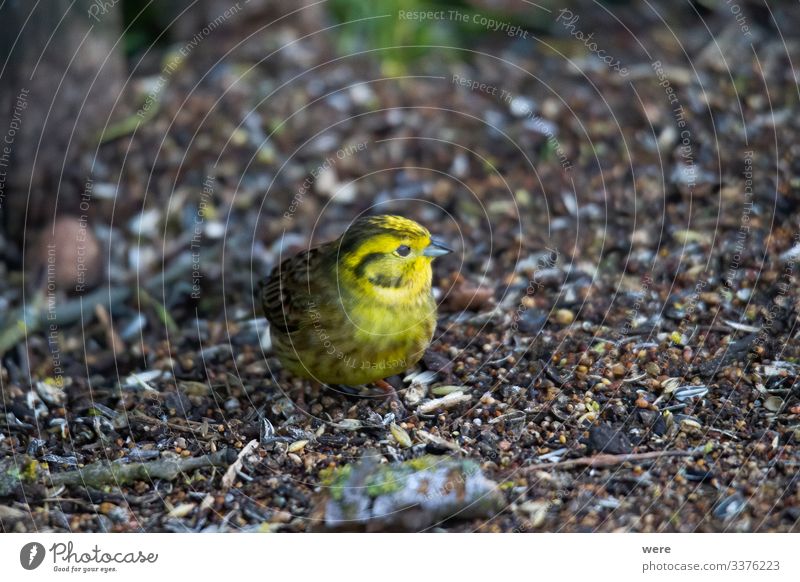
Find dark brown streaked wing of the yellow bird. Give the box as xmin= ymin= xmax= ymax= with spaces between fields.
xmin=259 ymin=248 xmax=322 ymax=333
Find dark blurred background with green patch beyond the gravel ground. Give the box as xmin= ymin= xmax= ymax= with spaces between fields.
xmin=0 ymin=0 xmax=797 ymax=249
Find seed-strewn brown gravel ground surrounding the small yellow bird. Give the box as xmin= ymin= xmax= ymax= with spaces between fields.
xmin=0 ymin=3 xmax=800 ymax=532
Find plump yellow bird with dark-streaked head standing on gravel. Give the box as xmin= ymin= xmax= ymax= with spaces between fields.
xmin=261 ymin=215 xmax=451 ymax=388
